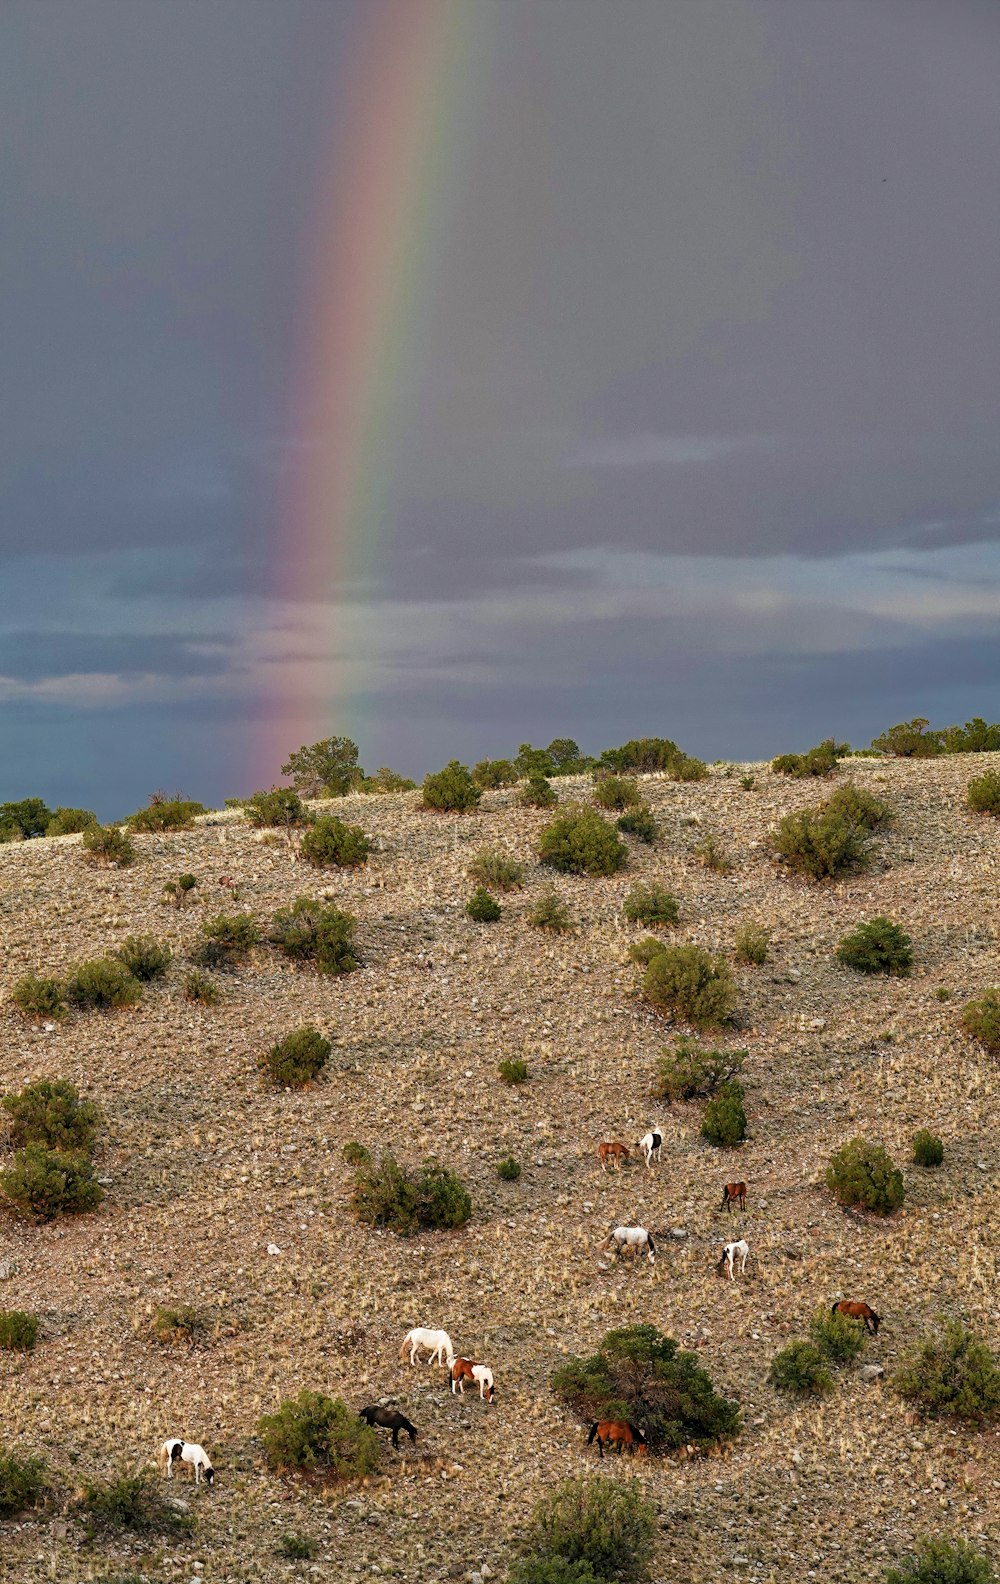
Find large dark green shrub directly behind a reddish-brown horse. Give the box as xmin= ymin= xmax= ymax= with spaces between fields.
xmin=552 ymin=1326 xmax=740 ymax=1453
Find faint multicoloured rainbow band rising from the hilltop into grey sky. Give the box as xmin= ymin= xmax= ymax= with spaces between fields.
xmin=264 ymin=0 xmax=490 ymax=784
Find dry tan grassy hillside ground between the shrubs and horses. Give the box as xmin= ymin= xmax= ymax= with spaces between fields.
xmin=0 ymin=756 xmax=1000 ymax=1584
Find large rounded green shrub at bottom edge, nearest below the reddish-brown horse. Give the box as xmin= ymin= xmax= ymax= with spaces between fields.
xmin=510 ymin=1478 xmax=656 ymax=1584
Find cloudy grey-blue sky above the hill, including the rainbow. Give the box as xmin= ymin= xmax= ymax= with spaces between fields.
xmin=0 ymin=0 xmax=1000 ymax=817
